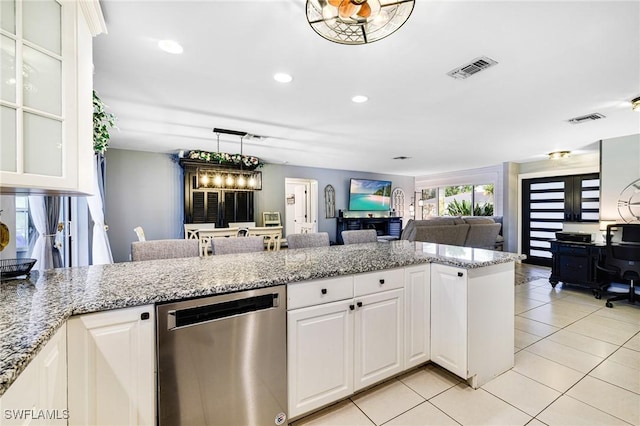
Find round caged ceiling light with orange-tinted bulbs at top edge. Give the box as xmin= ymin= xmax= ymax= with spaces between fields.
xmin=307 ymin=0 xmax=415 ymax=44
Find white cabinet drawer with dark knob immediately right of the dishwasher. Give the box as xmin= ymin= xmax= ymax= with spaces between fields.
xmin=287 ymin=276 xmax=353 ymax=310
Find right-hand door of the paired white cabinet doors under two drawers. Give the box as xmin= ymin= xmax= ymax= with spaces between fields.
xmin=353 ymin=289 xmax=404 ymax=390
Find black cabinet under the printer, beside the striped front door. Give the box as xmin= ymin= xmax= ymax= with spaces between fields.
xmin=549 ymin=240 xmax=606 ymax=296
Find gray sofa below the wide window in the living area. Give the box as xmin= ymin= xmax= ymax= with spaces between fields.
xmin=400 ymin=216 xmax=503 ymax=249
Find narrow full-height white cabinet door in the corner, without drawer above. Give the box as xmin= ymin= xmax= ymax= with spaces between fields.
xmin=404 ymin=264 xmax=431 ymax=369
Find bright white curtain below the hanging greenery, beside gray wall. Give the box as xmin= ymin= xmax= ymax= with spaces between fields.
xmin=87 ymin=155 xmax=113 ymax=265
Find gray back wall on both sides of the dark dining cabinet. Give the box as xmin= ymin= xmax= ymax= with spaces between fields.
xmin=105 ymin=148 xmax=414 ymax=262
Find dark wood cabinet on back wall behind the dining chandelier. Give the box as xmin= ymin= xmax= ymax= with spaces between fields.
xmin=181 ymin=161 xmax=254 ymax=228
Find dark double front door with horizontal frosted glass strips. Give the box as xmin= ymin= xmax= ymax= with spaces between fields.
xmin=522 ymin=173 xmax=600 ymax=266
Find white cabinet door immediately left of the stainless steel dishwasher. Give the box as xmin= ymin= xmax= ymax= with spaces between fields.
xmin=67 ymin=305 xmax=155 ymax=425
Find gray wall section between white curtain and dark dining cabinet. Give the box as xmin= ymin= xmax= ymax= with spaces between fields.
xmin=105 ymin=148 xmax=184 ymax=262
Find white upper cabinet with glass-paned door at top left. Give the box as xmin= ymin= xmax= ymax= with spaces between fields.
xmin=0 ymin=0 xmax=105 ymax=194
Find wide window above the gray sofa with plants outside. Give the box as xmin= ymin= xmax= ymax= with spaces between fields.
xmin=418 ymin=183 xmax=494 ymax=218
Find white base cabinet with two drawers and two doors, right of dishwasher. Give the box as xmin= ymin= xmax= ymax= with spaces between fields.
xmin=287 ymin=269 xmax=404 ymax=418
